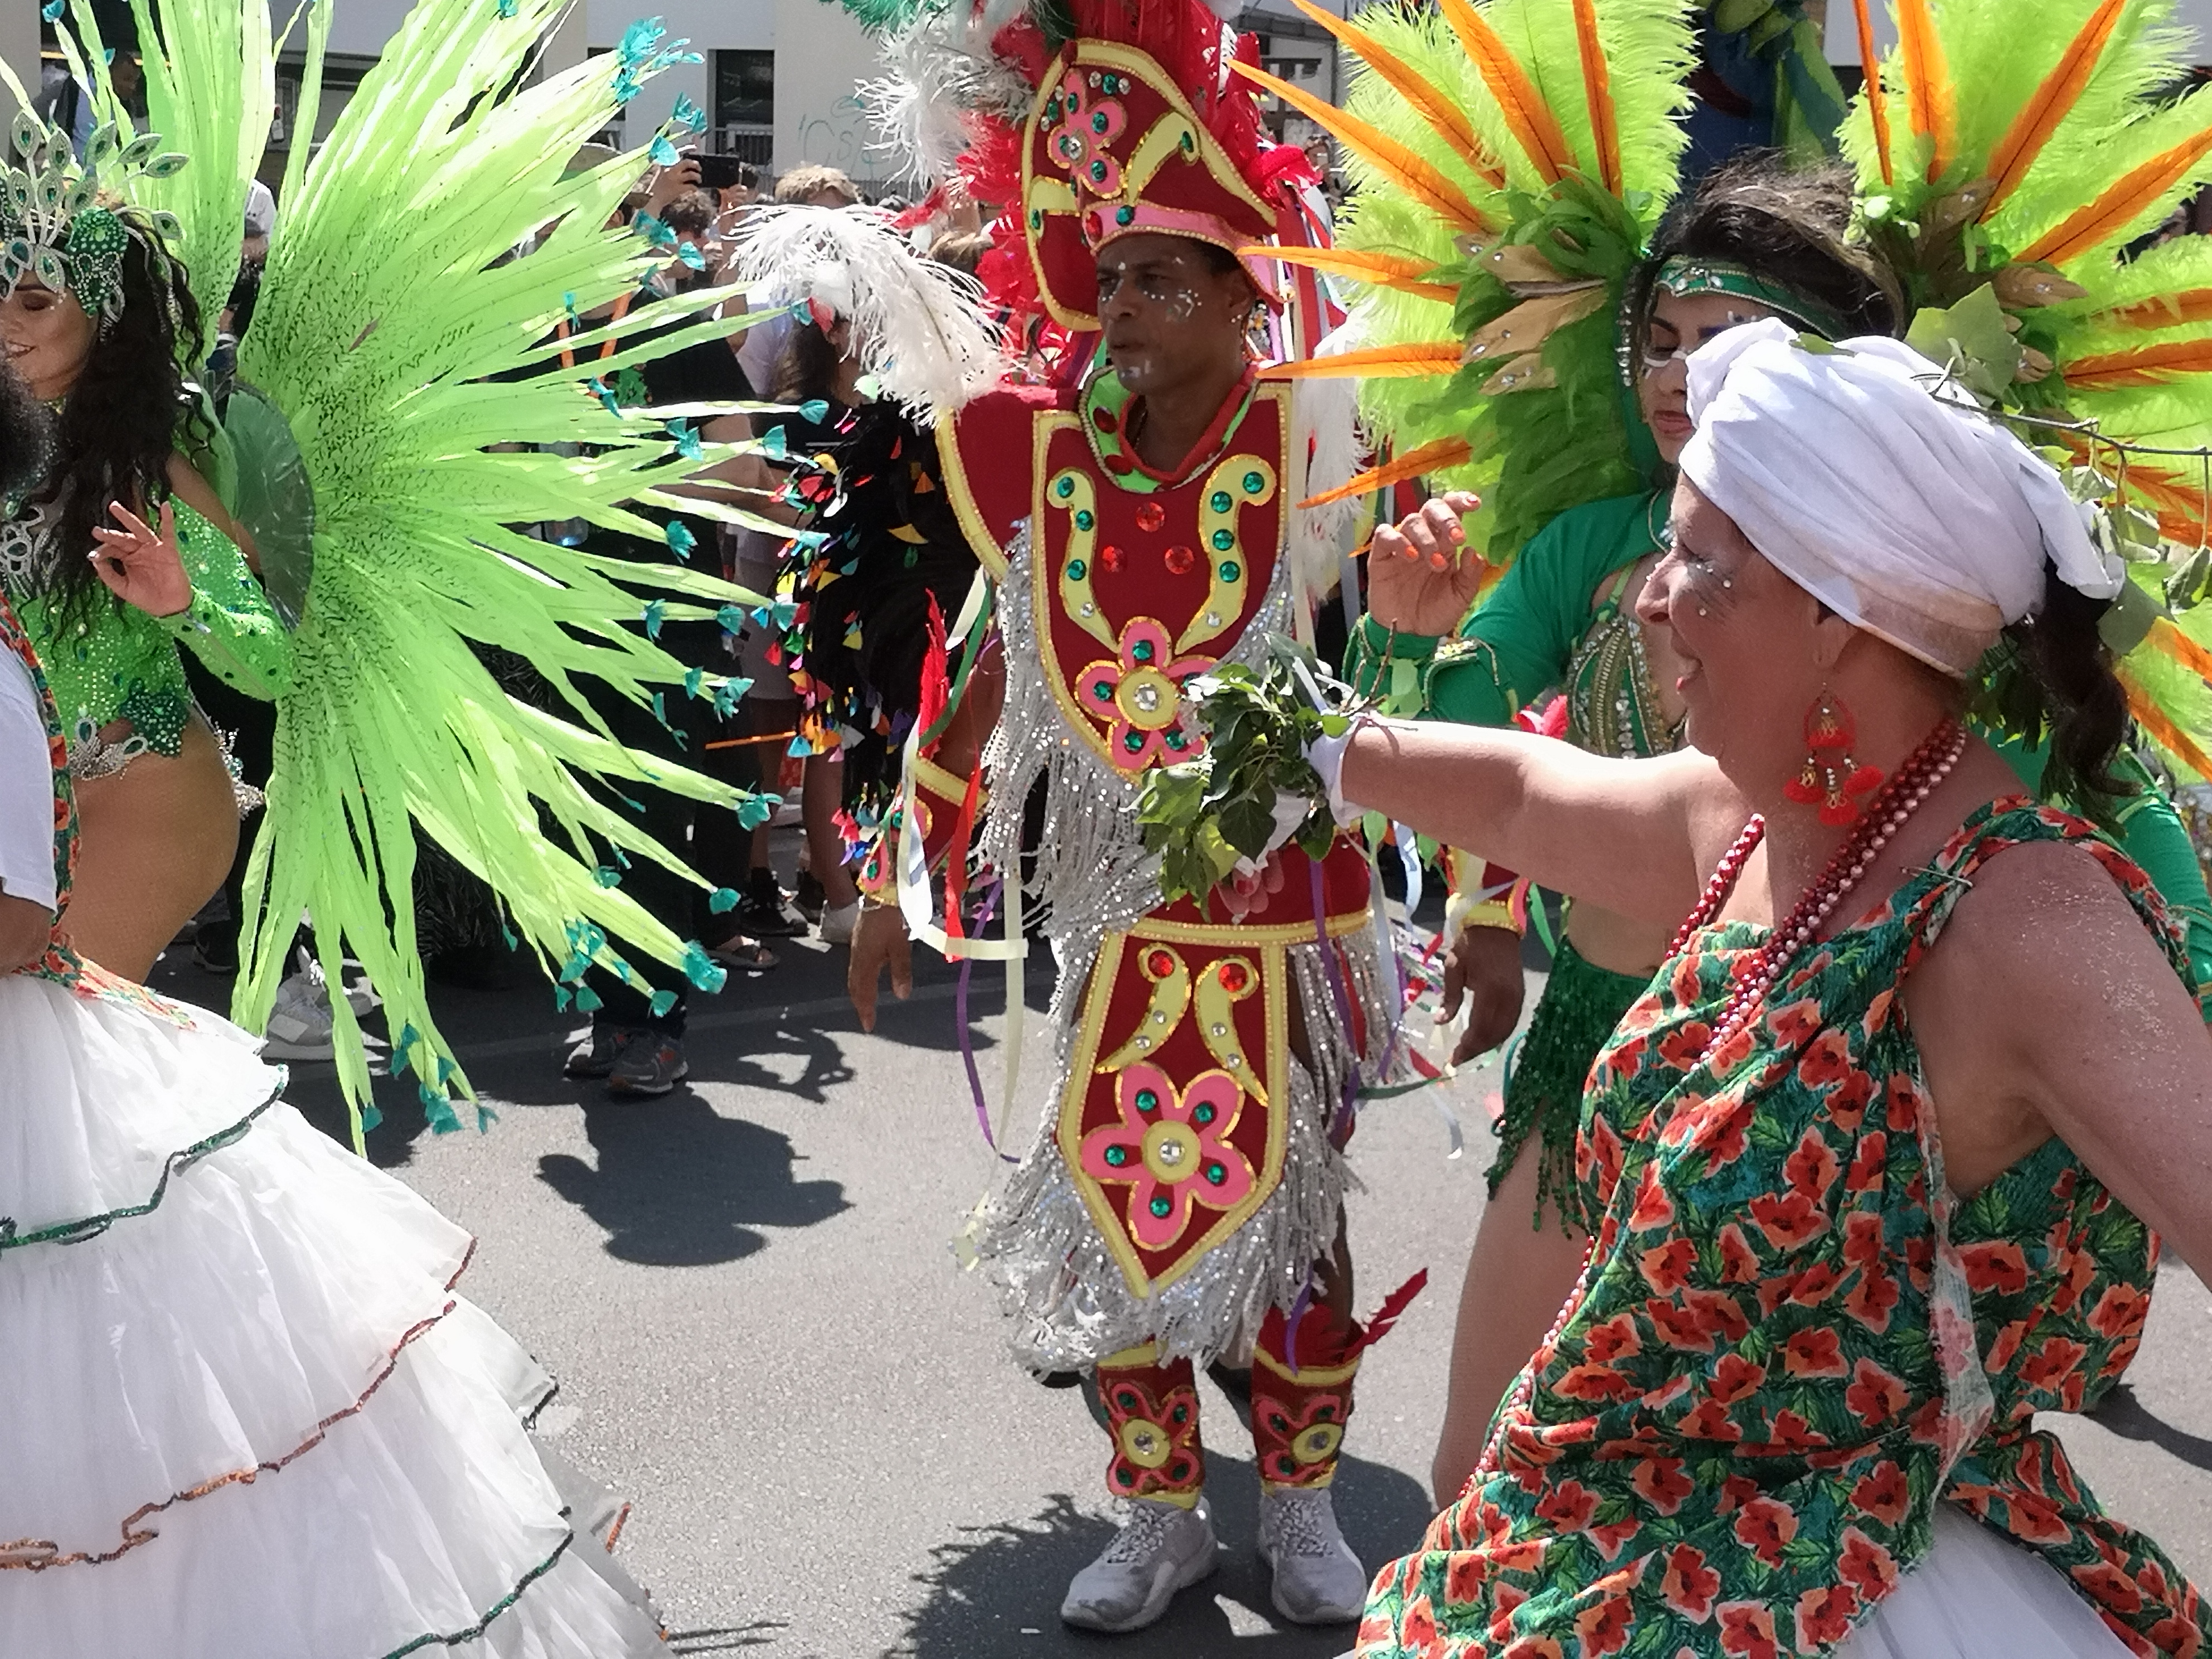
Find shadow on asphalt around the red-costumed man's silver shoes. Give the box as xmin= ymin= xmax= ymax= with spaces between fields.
xmin=891 ymin=1429 xmax=1429 ymax=1659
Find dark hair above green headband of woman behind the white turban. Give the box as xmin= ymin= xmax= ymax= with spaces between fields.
xmin=1622 ymin=151 xmax=1907 ymax=361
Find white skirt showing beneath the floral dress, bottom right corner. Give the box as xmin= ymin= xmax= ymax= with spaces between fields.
xmin=1836 ymin=1504 xmax=2128 ymax=1659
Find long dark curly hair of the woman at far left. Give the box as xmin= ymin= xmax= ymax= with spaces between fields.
xmin=31 ymin=217 xmax=206 ymax=622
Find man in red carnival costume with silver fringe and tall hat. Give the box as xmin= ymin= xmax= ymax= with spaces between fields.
xmin=852 ymin=0 xmax=1394 ymax=1630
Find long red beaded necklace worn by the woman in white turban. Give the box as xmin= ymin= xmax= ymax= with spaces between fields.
xmin=1460 ymin=719 xmax=1967 ymax=1497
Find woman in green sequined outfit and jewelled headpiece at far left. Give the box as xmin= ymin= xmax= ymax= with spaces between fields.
xmin=0 ymin=110 xmax=290 ymax=980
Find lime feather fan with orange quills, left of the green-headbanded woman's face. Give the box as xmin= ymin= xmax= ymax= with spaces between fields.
xmin=1247 ymin=0 xmax=1692 ymax=566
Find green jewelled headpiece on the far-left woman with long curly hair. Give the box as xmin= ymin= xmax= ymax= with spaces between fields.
xmin=0 ymin=110 xmax=183 ymax=318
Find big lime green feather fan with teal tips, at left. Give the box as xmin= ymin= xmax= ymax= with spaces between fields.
xmin=43 ymin=0 xmax=777 ymax=1135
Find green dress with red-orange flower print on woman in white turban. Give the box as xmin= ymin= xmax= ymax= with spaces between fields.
xmin=1358 ymin=796 xmax=2212 ymax=1659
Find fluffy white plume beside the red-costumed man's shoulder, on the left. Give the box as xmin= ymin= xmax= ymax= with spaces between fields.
xmin=734 ymin=206 xmax=1000 ymax=420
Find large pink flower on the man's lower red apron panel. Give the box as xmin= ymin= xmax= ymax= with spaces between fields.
xmin=1081 ymin=1064 xmax=1252 ymax=1250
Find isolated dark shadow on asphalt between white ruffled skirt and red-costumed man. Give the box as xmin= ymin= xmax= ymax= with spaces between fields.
xmin=537 ymin=1088 xmax=852 ymax=1268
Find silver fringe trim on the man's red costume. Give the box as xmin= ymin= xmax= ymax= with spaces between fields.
xmin=976 ymin=535 xmax=1391 ymax=1371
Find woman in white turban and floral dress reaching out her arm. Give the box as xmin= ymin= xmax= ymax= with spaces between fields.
xmin=1314 ymin=323 xmax=2212 ymax=1659
